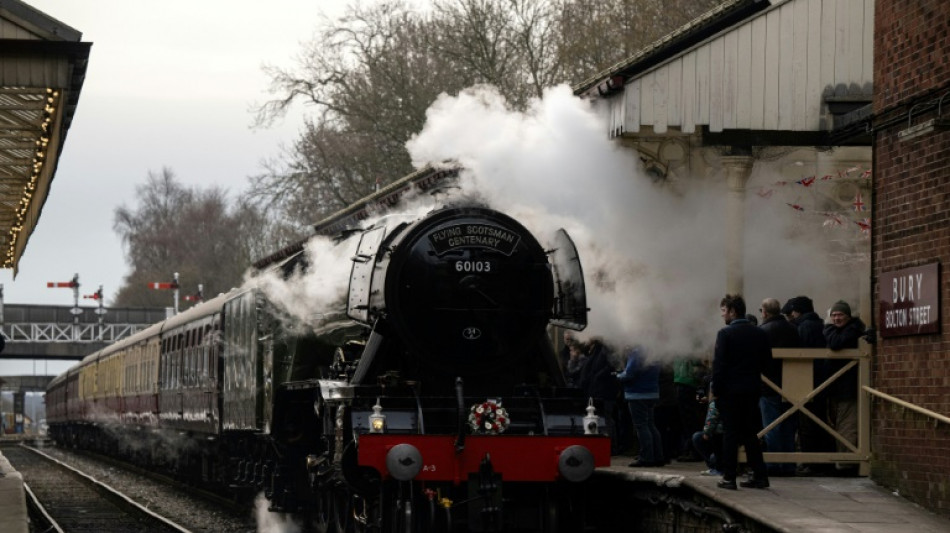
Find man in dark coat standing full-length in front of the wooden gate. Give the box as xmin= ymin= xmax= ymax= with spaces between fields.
xmin=712 ymin=294 xmax=772 ymax=490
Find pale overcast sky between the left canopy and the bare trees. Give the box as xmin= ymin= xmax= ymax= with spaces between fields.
xmin=0 ymin=0 xmax=345 ymax=306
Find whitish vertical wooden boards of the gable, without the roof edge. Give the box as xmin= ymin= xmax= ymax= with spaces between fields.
xmin=599 ymin=0 xmax=874 ymax=136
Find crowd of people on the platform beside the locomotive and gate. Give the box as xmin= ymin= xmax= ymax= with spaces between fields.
xmin=562 ymin=295 xmax=870 ymax=490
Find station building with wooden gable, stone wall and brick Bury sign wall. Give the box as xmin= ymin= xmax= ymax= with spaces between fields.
xmin=575 ymin=0 xmax=950 ymax=516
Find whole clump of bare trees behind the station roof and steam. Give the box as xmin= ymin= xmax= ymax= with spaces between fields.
xmin=246 ymin=0 xmax=716 ymax=233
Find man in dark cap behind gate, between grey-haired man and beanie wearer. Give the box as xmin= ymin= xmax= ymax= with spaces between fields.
xmin=782 ymin=296 xmax=835 ymax=476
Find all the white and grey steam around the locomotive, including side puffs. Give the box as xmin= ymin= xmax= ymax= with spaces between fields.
xmin=262 ymin=86 xmax=857 ymax=357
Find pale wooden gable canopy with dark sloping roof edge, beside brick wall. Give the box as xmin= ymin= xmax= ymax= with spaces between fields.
xmin=575 ymin=0 xmax=874 ymax=146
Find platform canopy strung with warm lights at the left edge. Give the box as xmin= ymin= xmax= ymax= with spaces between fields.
xmin=0 ymin=0 xmax=92 ymax=275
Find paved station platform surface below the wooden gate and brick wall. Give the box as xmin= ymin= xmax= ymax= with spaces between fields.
xmin=604 ymin=456 xmax=950 ymax=533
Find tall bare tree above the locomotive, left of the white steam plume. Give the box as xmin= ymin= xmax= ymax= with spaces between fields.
xmin=246 ymin=2 xmax=471 ymax=220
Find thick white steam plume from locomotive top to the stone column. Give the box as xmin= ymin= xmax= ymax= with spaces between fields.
xmin=408 ymin=86 xmax=725 ymax=355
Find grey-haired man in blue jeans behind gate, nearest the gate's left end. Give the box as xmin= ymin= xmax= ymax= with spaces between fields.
xmin=759 ymin=298 xmax=801 ymax=476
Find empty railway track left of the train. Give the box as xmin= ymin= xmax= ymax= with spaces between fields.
xmin=3 ymin=446 xmax=189 ymax=533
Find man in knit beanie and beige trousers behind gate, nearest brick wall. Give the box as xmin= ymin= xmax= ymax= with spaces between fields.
xmin=825 ymin=300 xmax=867 ymax=473
